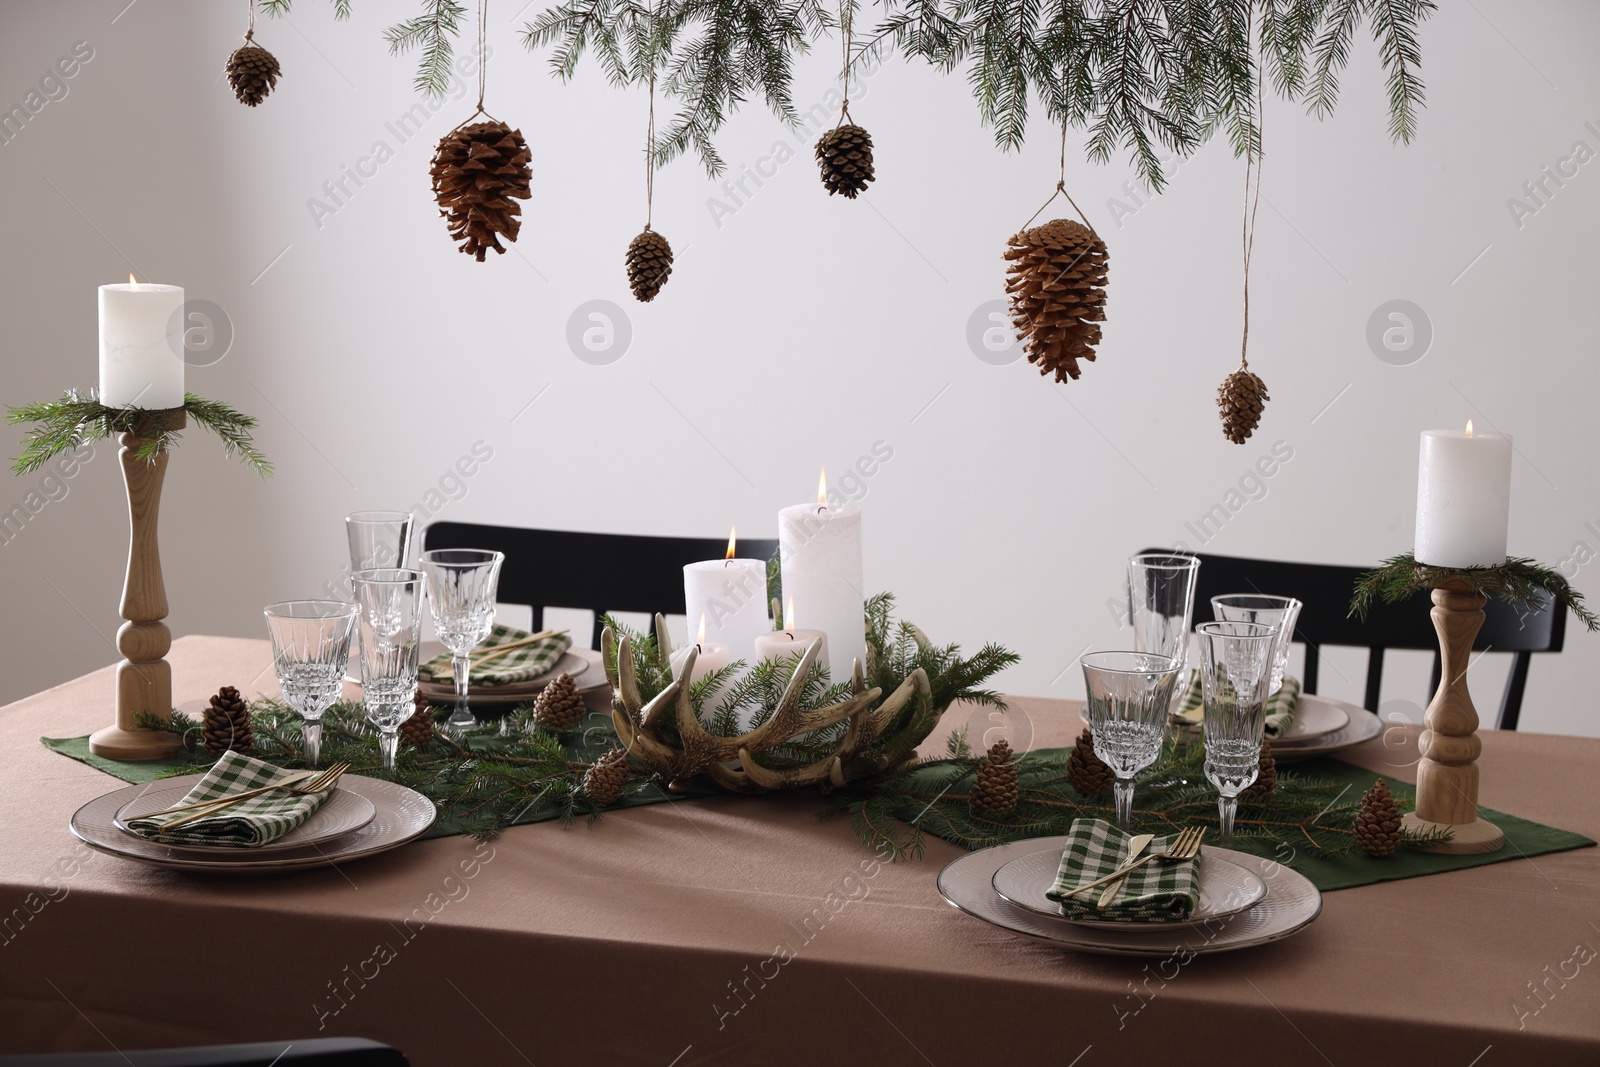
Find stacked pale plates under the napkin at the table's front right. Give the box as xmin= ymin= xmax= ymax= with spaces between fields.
xmin=939 ymin=837 xmax=1322 ymax=957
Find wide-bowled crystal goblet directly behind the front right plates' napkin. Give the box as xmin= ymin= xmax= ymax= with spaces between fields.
xmin=1083 ymin=653 xmax=1178 ymax=830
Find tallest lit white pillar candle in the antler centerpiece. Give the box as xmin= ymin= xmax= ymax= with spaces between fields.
xmin=778 ymin=472 xmax=867 ymax=681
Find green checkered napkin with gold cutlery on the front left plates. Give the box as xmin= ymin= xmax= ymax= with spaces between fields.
xmin=128 ymin=750 xmax=330 ymax=848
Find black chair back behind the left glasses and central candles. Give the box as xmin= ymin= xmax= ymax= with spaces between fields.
xmin=422 ymin=523 xmax=778 ymax=648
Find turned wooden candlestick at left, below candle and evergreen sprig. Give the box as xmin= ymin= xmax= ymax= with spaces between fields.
xmin=90 ymin=422 xmax=187 ymax=760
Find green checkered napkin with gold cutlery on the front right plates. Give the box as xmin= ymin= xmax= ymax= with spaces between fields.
xmin=1045 ymin=819 xmax=1200 ymax=923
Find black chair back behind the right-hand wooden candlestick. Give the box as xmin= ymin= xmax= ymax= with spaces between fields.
xmin=1150 ymin=549 xmax=1566 ymax=729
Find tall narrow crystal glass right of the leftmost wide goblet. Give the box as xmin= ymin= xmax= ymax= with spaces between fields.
xmin=352 ymin=568 xmax=426 ymax=771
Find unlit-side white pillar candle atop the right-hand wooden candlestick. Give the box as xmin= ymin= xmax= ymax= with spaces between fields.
xmin=1414 ymin=422 xmax=1510 ymax=568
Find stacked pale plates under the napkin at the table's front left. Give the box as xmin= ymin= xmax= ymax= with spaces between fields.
xmin=70 ymin=774 xmax=437 ymax=875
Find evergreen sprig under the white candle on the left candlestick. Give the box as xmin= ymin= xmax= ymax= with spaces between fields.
xmin=6 ymin=389 xmax=272 ymax=477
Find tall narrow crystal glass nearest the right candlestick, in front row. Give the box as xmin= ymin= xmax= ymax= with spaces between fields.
xmin=1195 ymin=622 xmax=1278 ymax=846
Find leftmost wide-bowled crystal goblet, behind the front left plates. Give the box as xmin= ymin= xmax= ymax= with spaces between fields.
xmin=262 ymin=600 xmax=355 ymax=766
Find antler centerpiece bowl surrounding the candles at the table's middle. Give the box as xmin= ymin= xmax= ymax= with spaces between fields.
xmin=603 ymin=614 xmax=939 ymax=793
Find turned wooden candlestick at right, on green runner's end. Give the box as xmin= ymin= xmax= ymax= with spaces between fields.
xmin=1402 ymin=579 xmax=1506 ymax=854
